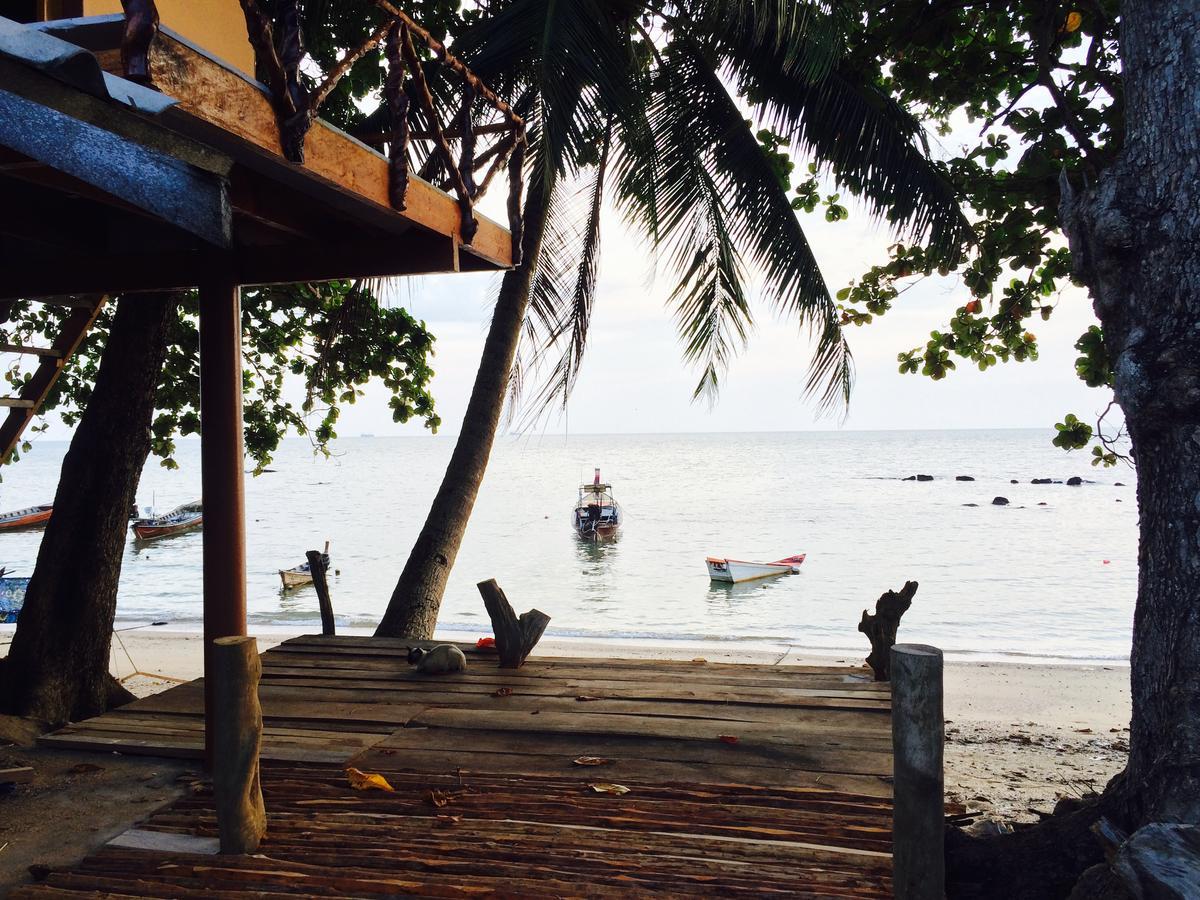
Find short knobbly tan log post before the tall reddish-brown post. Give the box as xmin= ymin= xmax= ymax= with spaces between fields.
xmin=206 ymin=637 xmax=266 ymax=853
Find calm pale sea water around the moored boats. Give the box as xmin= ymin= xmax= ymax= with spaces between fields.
xmin=0 ymin=430 xmax=1136 ymax=660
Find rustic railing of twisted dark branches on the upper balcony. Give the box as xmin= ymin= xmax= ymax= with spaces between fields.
xmin=121 ymin=0 xmax=526 ymax=265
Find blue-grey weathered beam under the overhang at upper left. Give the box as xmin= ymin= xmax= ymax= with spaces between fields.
xmin=0 ymin=90 xmax=233 ymax=247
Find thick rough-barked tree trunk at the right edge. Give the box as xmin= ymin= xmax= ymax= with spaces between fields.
xmin=1063 ymin=0 xmax=1200 ymax=832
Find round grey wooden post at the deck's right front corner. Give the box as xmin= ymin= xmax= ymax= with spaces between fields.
xmin=892 ymin=643 xmax=946 ymax=900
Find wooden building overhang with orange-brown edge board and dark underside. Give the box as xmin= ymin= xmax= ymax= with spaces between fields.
xmin=0 ymin=16 xmax=512 ymax=298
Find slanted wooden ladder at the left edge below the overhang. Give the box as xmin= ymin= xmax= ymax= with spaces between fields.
xmin=0 ymin=294 xmax=108 ymax=464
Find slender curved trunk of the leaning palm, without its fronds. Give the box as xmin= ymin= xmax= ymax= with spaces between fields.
xmin=376 ymin=179 xmax=546 ymax=641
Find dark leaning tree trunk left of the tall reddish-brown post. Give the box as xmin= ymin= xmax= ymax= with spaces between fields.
xmin=0 ymin=294 xmax=176 ymax=724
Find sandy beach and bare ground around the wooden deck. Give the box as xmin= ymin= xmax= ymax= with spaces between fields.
xmin=0 ymin=628 xmax=1129 ymax=890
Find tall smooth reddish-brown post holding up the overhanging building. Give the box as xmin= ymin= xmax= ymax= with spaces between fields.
xmin=200 ymin=276 xmax=246 ymax=767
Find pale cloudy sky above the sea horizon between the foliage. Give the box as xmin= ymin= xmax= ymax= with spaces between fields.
xmin=338 ymin=192 xmax=1109 ymax=436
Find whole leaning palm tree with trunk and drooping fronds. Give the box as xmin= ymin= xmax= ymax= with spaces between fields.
xmin=377 ymin=0 xmax=970 ymax=638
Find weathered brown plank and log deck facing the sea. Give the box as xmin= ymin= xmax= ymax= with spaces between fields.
xmin=23 ymin=637 xmax=892 ymax=898
